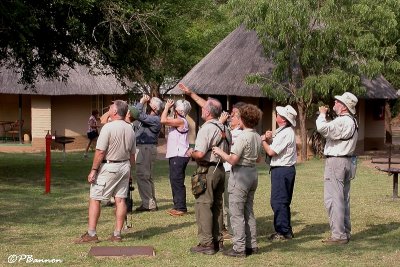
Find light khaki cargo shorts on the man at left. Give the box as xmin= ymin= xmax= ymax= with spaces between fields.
xmin=90 ymin=161 xmax=131 ymax=201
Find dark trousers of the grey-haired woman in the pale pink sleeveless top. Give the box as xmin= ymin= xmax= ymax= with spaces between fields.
xmin=169 ymin=157 xmax=189 ymax=212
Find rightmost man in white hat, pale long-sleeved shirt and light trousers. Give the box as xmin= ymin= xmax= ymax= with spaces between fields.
xmin=316 ymin=92 xmax=358 ymax=244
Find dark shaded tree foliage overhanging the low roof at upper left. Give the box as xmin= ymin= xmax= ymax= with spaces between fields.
xmin=0 ymin=0 xmax=157 ymax=85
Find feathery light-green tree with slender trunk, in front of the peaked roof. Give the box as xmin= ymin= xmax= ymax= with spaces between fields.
xmin=228 ymin=0 xmax=400 ymax=160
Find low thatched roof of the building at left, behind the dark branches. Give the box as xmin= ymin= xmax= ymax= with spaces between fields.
xmin=0 ymin=66 xmax=126 ymax=95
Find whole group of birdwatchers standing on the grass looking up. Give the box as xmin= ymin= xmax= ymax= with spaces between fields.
xmin=76 ymin=84 xmax=358 ymax=257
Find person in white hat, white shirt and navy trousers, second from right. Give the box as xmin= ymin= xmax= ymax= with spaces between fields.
xmin=261 ymin=105 xmax=297 ymax=241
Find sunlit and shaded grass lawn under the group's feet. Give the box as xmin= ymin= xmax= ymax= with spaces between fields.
xmin=0 ymin=152 xmax=400 ymax=266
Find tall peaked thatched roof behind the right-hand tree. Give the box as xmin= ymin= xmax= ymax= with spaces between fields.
xmin=170 ymin=26 xmax=398 ymax=99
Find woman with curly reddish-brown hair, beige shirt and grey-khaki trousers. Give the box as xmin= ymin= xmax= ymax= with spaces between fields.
xmin=213 ymin=104 xmax=262 ymax=257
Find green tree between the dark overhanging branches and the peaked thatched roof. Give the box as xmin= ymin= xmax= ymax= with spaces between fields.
xmin=103 ymin=0 xmax=230 ymax=95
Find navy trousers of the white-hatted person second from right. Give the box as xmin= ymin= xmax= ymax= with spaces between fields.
xmin=271 ymin=166 xmax=296 ymax=235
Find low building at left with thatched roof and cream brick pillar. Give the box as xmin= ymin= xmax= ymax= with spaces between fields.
xmin=0 ymin=66 xmax=127 ymax=152
